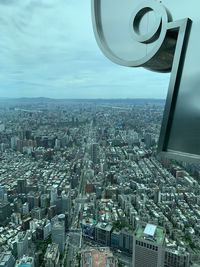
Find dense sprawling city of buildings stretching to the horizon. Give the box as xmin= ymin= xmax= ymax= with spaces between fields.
xmin=0 ymin=97 xmax=200 ymax=267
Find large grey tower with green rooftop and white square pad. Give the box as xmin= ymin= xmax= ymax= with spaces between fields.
xmin=133 ymin=224 xmax=165 ymax=267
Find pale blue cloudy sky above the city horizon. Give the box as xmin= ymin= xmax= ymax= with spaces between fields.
xmin=0 ymin=0 xmax=169 ymax=98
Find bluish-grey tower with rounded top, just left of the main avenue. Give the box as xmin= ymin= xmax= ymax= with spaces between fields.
xmin=51 ymin=221 xmax=65 ymax=253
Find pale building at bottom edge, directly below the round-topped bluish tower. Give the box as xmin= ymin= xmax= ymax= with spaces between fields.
xmin=44 ymin=243 xmax=60 ymax=267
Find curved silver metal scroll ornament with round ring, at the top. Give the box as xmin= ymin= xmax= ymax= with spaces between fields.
xmin=92 ymin=0 xmax=170 ymax=71
